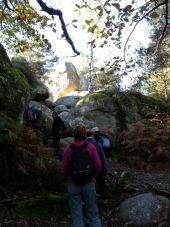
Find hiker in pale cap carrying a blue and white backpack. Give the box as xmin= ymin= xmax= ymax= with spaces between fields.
xmin=92 ymin=127 xmax=112 ymax=158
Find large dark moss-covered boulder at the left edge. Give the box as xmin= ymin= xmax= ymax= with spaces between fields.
xmin=0 ymin=44 xmax=31 ymax=143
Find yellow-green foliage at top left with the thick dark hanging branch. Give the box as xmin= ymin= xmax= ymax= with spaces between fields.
xmin=0 ymin=0 xmax=79 ymax=55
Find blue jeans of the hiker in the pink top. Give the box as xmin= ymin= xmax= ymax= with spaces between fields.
xmin=68 ymin=181 xmax=101 ymax=227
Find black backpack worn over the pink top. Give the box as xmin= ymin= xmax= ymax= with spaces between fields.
xmin=69 ymin=142 xmax=94 ymax=185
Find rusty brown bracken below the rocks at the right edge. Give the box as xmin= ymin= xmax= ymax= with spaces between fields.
xmin=113 ymin=117 xmax=170 ymax=168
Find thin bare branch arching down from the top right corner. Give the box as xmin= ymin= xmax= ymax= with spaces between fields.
xmin=124 ymin=0 xmax=168 ymax=64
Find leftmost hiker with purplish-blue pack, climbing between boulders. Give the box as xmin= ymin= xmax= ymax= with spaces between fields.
xmin=24 ymin=106 xmax=38 ymax=128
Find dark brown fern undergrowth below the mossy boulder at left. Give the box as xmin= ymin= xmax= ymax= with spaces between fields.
xmin=0 ymin=128 xmax=65 ymax=196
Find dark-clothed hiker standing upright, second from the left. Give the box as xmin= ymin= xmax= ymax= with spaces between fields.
xmin=51 ymin=111 xmax=65 ymax=157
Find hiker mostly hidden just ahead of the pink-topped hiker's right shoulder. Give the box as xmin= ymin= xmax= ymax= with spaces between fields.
xmin=86 ymin=130 xmax=107 ymax=199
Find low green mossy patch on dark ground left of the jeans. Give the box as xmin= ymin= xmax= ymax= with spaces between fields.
xmin=15 ymin=194 xmax=68 ymax=220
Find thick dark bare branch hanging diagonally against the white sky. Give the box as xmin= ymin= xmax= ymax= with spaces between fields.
xmin=37 ymin=0 xmax=80 ymax=55
